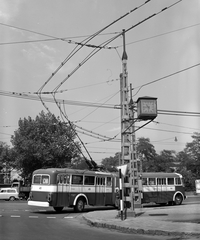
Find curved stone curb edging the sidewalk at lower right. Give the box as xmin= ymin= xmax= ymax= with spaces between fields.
xmin=83 ymin=215 xmax=200 ymax=238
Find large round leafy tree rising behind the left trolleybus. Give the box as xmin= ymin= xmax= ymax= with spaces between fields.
xmin=11 ymin=111 xmax=80 ymax=181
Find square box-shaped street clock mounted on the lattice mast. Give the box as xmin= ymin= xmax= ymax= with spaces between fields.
xmin=137 ymin=97 xmax=157 ymax=120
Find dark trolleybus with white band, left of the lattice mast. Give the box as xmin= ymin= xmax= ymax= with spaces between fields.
xmin=28 ymin=168 xmax=119 ymax=212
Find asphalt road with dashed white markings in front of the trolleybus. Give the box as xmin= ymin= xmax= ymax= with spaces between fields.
xmin=0 ymin=195 xmax=200 ymax=240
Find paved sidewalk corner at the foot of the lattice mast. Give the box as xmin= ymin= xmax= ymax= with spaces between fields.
xmin=83 ymin=204 xmax=200 ymax=238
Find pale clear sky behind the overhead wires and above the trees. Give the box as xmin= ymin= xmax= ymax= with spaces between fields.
xmin=0 ymin=0 xmax=200 ymax=163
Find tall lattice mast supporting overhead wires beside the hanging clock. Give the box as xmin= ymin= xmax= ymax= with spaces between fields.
xmin=119 ymin=30 xmax=141 ymax=219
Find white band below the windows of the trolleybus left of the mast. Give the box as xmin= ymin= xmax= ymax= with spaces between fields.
xmin=31 ymin=185 xmax=112 ymax=193
